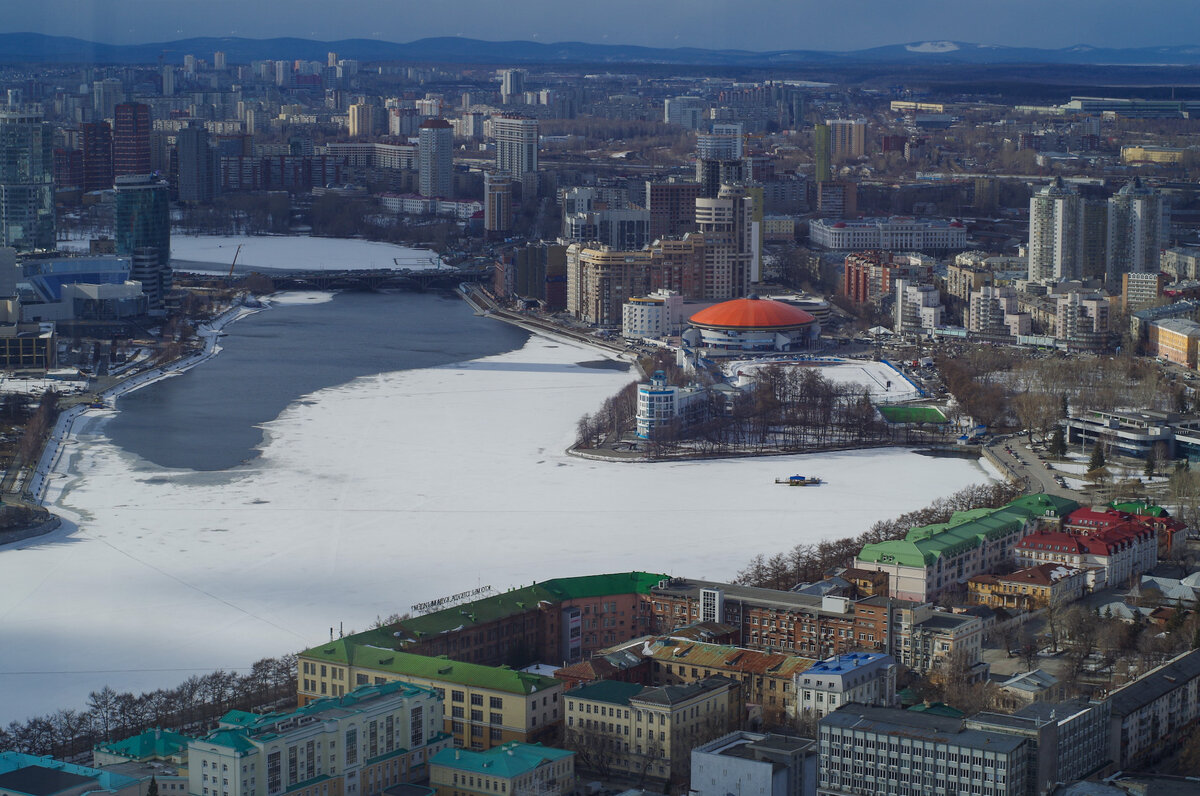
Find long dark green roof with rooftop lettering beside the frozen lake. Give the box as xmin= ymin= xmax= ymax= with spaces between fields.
xmin=392 ymin=571 xmax=667 ymax=639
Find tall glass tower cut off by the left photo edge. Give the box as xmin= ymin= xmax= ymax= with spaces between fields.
xmin=0 ymin=110 xmax=54 ymax=250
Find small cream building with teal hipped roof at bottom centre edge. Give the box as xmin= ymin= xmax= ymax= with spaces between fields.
xmin=430 ymin=742 xmax=575 ymax=796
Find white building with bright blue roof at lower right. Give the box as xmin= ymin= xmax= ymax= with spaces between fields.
xmin=793 ymin=652 xmax=896 ymax=718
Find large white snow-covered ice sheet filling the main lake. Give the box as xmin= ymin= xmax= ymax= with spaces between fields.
xmin=0 ymin=333 xmax=988 ymax=723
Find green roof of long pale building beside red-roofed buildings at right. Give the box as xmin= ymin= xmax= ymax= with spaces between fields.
xmin=858 ymin=495 xmax=1079 ymax=567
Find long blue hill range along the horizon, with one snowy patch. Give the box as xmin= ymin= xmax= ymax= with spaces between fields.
xmin=7 ymin=34 xmax=1200 ymax=67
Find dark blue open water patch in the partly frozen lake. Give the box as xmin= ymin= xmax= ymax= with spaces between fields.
xmin=106 ymin=293 xmax=528 ymax=471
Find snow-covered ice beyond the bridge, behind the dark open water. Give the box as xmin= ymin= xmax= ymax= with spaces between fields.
xmin=170 ymin=235 xmax=442 ymax=271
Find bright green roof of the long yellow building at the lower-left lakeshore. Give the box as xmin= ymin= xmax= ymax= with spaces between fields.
xmin=300 ymin=643 xmax=559 ymax=696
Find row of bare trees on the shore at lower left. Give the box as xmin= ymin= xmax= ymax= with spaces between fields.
xmin=0 ymin=656 xmax=296 ymax=760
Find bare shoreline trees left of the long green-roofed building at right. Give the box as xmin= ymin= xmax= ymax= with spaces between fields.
xmin=734 ymin=481 xmax=1020 ymax=589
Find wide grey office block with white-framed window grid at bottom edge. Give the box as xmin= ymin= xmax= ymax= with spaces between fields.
xmin=817 ymin=705 xmax=1034 ymax=796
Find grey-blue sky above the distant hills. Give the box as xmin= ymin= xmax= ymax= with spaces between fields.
xmin=9 ymin=0 xmax=1200 ymax=50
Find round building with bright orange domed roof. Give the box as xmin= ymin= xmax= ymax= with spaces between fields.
xmin=684 ymin=295 xmax=821 ymax=352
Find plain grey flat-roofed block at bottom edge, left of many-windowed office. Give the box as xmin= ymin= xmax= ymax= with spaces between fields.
xmin=688 ymin=730 xmax=818 ymax=796
